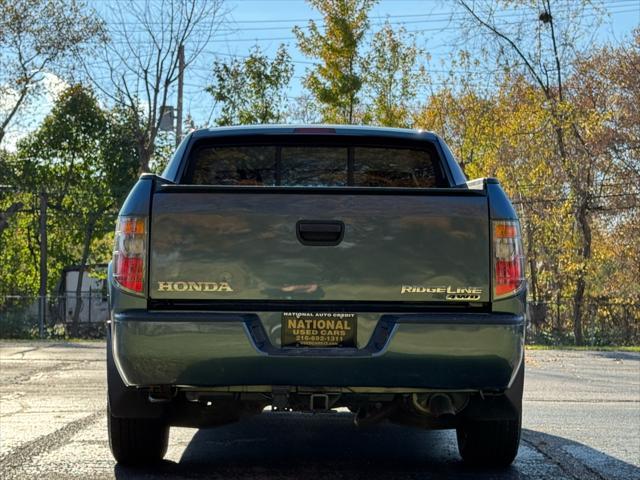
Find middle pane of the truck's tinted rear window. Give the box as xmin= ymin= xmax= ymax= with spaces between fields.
xmin=281 ymin=146 xmax=348 ymax=187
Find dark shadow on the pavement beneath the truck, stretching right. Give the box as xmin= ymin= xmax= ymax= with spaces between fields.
xmin=115 ymin=413 xmax=640 ymax=480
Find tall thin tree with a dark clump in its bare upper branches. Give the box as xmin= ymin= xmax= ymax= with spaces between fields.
xmin=458 ymin=0 xmax=602 ymax=344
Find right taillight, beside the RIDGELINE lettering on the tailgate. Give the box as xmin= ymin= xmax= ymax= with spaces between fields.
xmin=493 ymin=220 xmax=524 ymax=298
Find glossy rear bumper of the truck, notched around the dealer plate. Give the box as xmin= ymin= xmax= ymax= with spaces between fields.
xmin=112 ymin=310 xmax=524 ymax=391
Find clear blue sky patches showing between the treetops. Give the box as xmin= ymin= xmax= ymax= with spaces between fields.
xmin=5 ymin=0 xmax=640 ymax=148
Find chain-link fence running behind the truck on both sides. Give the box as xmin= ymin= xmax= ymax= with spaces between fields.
xmin=0 ymin=291 xmax=640 ymax=346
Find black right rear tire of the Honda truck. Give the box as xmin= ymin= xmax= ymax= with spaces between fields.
xmin=456 ymin=416 xmax=521 ymax=467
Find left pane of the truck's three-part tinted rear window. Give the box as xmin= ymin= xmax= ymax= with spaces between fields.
xmin=192 ymin=146 xmax=276 ymax=185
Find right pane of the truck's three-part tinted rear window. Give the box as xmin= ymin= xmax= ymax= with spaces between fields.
xmin=353 ymin=147 xmax=438 ymax=188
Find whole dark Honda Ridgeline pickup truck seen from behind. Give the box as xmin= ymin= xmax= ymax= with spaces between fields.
xmin=107 ymin=126 xmax=526 ymax=466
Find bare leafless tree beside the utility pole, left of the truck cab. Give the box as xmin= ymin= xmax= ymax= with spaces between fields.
xmin=91 ymin=0 xmax=223 ymax=172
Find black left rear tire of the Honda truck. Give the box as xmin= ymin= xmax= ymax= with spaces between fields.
xmin=107 ymin=407 xmax=169 ymax=465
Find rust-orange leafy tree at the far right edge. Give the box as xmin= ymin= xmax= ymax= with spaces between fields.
xmin=566 ymin=29 xmax=640 ymax=308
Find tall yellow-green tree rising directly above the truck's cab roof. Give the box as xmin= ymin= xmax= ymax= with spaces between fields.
xmin=294 ymin=0 xmax=376 ymax=123
